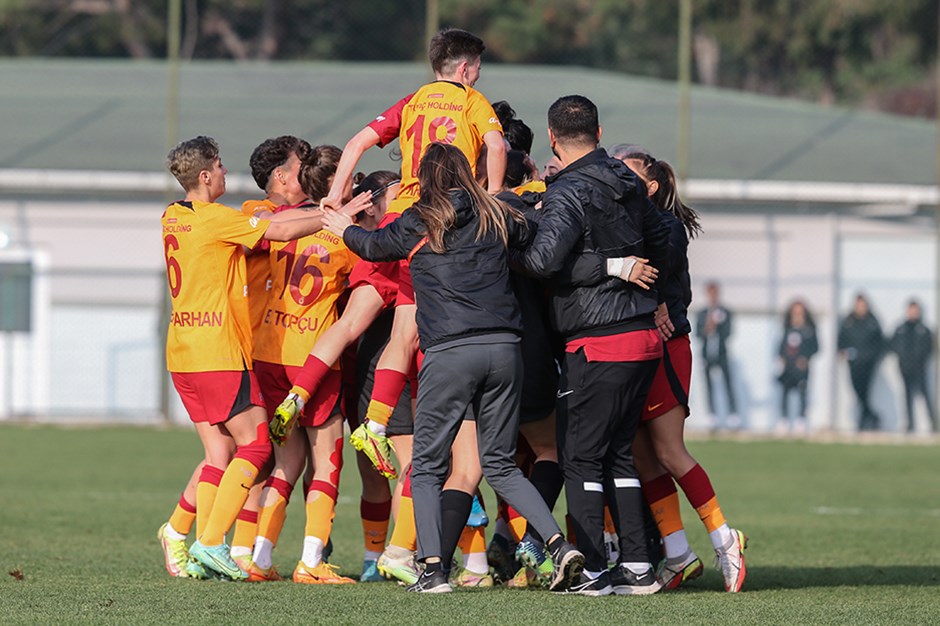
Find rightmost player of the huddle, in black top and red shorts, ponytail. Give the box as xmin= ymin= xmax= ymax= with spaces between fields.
xmin=622 ymin=145 xmax=747 ymax=592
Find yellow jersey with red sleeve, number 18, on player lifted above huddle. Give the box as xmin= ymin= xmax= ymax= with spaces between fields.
xmin=369 ymin=80 xmax=503 ymax=198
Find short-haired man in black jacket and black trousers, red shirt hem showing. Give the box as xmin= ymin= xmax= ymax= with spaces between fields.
xmin=515 ymin=96 xmax=669 ymax=595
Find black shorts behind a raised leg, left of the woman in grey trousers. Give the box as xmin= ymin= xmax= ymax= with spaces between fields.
xmin=356 ymin=308 xmax=414 ymax=436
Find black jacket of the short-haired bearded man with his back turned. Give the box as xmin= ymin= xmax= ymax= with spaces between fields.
xmin=515 ymin=149 xmax=669 ymax=339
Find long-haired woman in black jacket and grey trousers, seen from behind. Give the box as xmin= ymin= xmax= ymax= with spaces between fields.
xmin=326 ymin=143 xmax=583 ymax=593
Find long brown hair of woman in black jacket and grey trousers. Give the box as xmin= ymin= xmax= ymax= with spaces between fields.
xmin=412 ymin=142 xmax=524 ymax=254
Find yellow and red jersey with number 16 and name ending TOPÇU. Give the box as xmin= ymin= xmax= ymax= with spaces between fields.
xmin=254 ymin=224 xmax=359 ymax=366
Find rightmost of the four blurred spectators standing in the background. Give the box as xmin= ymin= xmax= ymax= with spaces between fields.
xmin=890 ymin=300 xmax=937 ymax=433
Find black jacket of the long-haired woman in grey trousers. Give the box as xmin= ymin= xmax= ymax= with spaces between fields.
xmin=343 ymin=185 xmax=528 ymax=350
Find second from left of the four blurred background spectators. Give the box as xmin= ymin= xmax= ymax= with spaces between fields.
xmin=777 ymin=300 xmax=819 ymax=434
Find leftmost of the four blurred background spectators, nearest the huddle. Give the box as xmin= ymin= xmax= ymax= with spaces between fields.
xmin=695 ymin=282 xmax=741 ymax=429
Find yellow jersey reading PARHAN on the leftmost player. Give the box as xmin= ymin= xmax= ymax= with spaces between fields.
xmin=161 ymin=201 xmax=271 ymax=372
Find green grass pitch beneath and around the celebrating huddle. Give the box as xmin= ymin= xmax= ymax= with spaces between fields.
xmin=0 ymin=425 xmax=940 ymax=625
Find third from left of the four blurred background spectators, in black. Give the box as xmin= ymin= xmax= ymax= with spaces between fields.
xmin=837 ymin=294 xmax=885 ymax=432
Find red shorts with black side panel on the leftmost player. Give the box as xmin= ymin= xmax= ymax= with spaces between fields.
xmin=170 ymin=371 xmax=265 ymax=425
